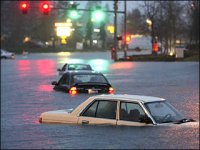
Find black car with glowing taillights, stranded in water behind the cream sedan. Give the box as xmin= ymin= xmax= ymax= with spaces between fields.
xmin=52 ymin=71 xmax=114 ymax=95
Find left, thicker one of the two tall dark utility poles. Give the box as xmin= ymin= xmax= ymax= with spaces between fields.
xmin=114 ymin=0 xmax=118 ymax=61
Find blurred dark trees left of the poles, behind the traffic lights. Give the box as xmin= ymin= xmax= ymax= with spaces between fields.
xmin=1 ymin=1 xmax=110 ymax=48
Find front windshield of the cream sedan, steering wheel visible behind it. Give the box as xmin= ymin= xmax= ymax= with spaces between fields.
xmin=145 ymin=101 xmax=184 ymax=123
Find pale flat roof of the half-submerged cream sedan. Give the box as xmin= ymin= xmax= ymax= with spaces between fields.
xmin=91 ymin=94 xmax=165 ymax=103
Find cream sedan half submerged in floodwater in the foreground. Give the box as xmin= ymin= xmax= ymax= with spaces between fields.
xmin=39 ymin=95 xmax=194 ymax=126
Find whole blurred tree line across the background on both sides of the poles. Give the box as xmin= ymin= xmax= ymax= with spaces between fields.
xmin=1 ymin=0 xmax=199 ymax=53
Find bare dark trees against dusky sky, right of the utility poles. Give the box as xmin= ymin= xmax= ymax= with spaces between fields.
xmin=127 ymin=0 xmax=199 ymax=53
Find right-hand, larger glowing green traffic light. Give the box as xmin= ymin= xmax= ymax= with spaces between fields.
xmin=92 ymin=6 xmax=105 ymax=22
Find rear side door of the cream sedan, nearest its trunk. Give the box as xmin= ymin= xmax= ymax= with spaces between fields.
xmin=78 ymin=100 xmax=117 ymax=125
